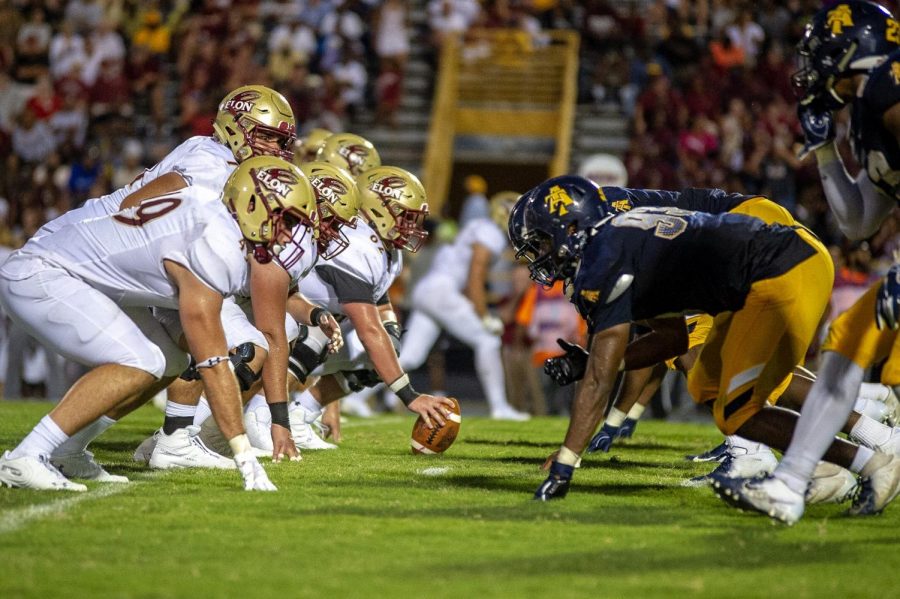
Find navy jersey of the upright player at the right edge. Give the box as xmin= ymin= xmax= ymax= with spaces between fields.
xmin=850 ymin=50 xmax=900 ymax=200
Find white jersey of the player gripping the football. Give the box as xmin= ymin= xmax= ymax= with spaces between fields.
xmin=300 ymin=219 xmax=403 ymax=314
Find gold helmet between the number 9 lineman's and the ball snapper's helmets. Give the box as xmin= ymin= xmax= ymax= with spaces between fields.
xmin=300 ymin=162 xmax=359 ymax=260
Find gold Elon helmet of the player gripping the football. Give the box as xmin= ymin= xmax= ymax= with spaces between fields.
xmin=356 ymin=166 xmax=428 ymax=252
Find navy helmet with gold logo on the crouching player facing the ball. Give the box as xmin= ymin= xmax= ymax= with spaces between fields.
xmin=509 ymin=175 xmax=610 ymax=287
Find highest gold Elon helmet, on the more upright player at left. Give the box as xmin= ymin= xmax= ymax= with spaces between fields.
xmin=213 ymin=85 xmax=296 ymax=162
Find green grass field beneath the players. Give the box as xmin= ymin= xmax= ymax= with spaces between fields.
xmin=0 ymin=402 xmax=900 ymax=599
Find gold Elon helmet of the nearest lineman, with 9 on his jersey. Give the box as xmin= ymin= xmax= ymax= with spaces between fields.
xmin=222 ymin=156 xmax=319 ymax=269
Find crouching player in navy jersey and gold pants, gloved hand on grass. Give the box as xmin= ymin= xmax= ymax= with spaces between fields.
xmin=510 ymin=177 xmax=900 ymax=514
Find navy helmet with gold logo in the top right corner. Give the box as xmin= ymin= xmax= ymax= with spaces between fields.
xmin=791 ymin=0 xmax=900 ymax=110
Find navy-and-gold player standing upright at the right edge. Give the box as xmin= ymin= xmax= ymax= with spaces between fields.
xmin=723 ymin=1 xmax=900 ymax=521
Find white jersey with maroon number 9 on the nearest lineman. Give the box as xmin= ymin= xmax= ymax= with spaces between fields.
xmin=6 ymin=187 xmax=249 ymax=308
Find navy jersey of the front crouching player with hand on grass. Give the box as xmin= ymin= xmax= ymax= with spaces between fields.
xmin=572 ymin=208 xmax=815 ymax=333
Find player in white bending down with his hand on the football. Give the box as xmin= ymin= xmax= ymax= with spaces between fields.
xmin=291 ymin=166 xmax=452 ymax=438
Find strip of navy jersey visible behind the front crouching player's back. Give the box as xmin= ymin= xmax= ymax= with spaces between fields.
xmin=600 ymin=187 xmax=759 ymax=214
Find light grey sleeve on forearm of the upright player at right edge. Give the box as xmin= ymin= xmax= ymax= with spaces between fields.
xmin=816 ymin=143 xmax=895 ymax=239
